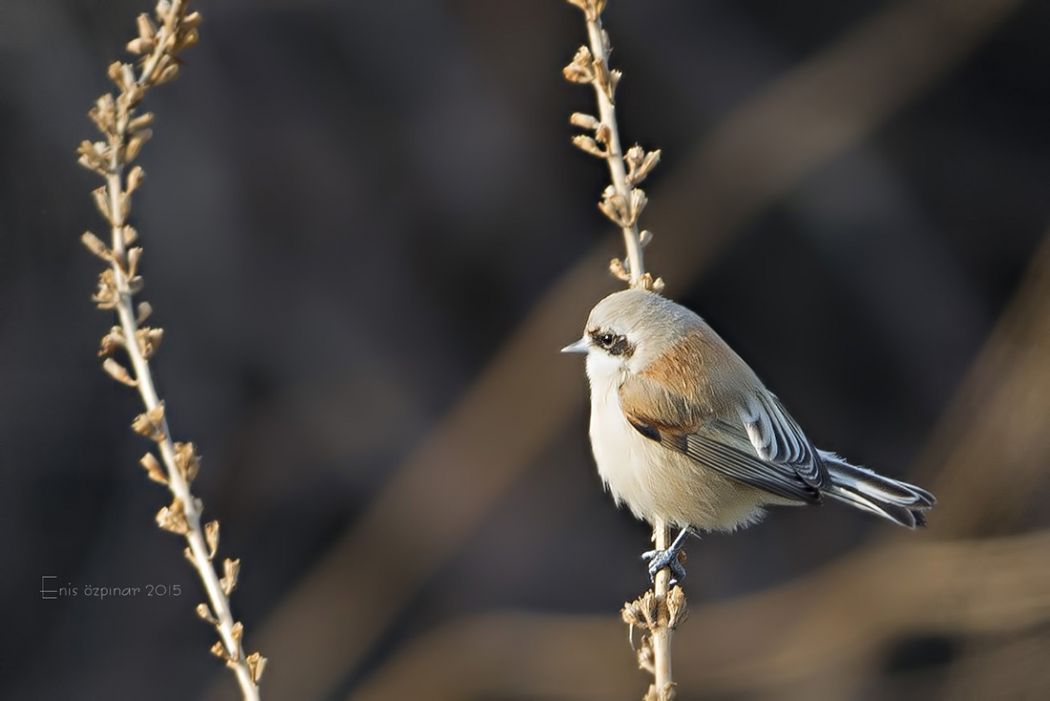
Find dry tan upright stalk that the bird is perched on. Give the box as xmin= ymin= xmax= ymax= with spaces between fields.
xmin=563 ymin=0 xmax=686 ymax=701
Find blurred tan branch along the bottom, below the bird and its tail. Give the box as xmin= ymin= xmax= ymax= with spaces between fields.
xmin=353 ymin=531 xmax=1050 ymax=701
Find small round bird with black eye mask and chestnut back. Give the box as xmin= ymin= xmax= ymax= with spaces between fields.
xmin=562 ymin=290 xmax=937 ymax=579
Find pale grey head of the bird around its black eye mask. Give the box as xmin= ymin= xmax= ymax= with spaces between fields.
xmin=585 ymin=290 xmax=706 ymax=369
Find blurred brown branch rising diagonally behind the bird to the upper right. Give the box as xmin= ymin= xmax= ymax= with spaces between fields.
xmin=229 ymin=0 xmax=1019 ymax=698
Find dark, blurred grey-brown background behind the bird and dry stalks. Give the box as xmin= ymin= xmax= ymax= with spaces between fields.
xmin=0 ymin=0 xmax=1050 ymax=700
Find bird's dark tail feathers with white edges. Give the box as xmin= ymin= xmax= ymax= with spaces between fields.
xmin=820 ymin=450 xmax=937 ymax=528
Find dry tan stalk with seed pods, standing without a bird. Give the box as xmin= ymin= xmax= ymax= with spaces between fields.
xmin=78 ymin=0 xmax=266 ymax=701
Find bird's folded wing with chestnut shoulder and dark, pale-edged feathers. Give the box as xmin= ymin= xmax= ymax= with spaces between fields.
xmin=620 ymin=375 xmax=827 ymax=503
